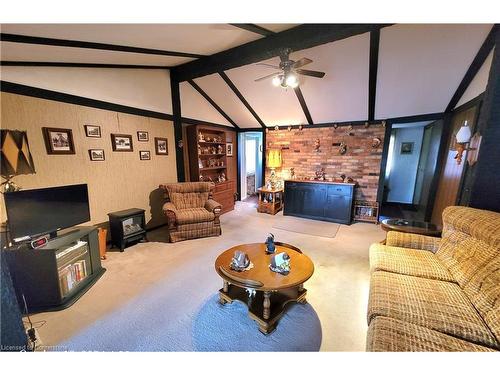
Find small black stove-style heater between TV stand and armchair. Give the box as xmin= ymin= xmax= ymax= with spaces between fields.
xmin=108 ymin=208 xmax=147 ymax=252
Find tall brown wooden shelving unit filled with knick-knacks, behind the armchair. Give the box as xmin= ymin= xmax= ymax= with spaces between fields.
xmin=187 ymin=125 xmax=234 ymax=213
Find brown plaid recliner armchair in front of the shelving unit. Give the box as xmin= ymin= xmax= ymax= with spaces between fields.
xmin=160 ymin=182 xmax=222 ymax=242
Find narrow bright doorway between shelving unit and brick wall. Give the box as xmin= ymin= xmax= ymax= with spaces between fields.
xmin=238 ymin=132 xmax=263 ymax=201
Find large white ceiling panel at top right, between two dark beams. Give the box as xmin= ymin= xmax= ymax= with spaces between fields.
xmin=375 ymin=24 xmax=492 ymax=119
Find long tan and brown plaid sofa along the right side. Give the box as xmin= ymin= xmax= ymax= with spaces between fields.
xmin=366 ymin=207 xmax=500 ymax=351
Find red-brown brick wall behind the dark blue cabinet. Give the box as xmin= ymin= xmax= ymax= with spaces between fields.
xmin=266 ymin=124 xmax=385 ymax=201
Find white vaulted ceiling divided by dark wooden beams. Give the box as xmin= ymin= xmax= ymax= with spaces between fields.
xmin=1 ymin=24 xmax=493 ymax=128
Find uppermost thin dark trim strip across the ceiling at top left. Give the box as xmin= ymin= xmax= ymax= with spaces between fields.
xmin=0 ymin=33 xmax=205 ymax=59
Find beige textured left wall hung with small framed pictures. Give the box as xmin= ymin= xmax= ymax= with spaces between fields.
xmin=1 ymin=93 xmax=177 ymax=231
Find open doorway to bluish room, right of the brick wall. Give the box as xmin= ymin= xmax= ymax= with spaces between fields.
xmin=380 ymin=120 xmax=443 ymax=221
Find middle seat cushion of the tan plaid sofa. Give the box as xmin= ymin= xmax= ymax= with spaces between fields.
xmin=368 ymin=271 xmax=498 ymax=348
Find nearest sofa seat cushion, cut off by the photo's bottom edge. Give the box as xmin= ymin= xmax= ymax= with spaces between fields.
xmin=366 ymin=316 xmax=493 ymax=352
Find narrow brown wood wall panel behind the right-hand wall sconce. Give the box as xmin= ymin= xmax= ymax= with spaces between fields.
xmin=431 ymin=106 xmax=477 ymax=226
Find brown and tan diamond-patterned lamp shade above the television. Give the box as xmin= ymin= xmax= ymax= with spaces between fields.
xmin=0 ymin=129 xmax=35 ymax=177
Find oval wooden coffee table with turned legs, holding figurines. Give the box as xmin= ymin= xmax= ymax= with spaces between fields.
xmin=215 ymin=243 xmax=314 ymax=334
